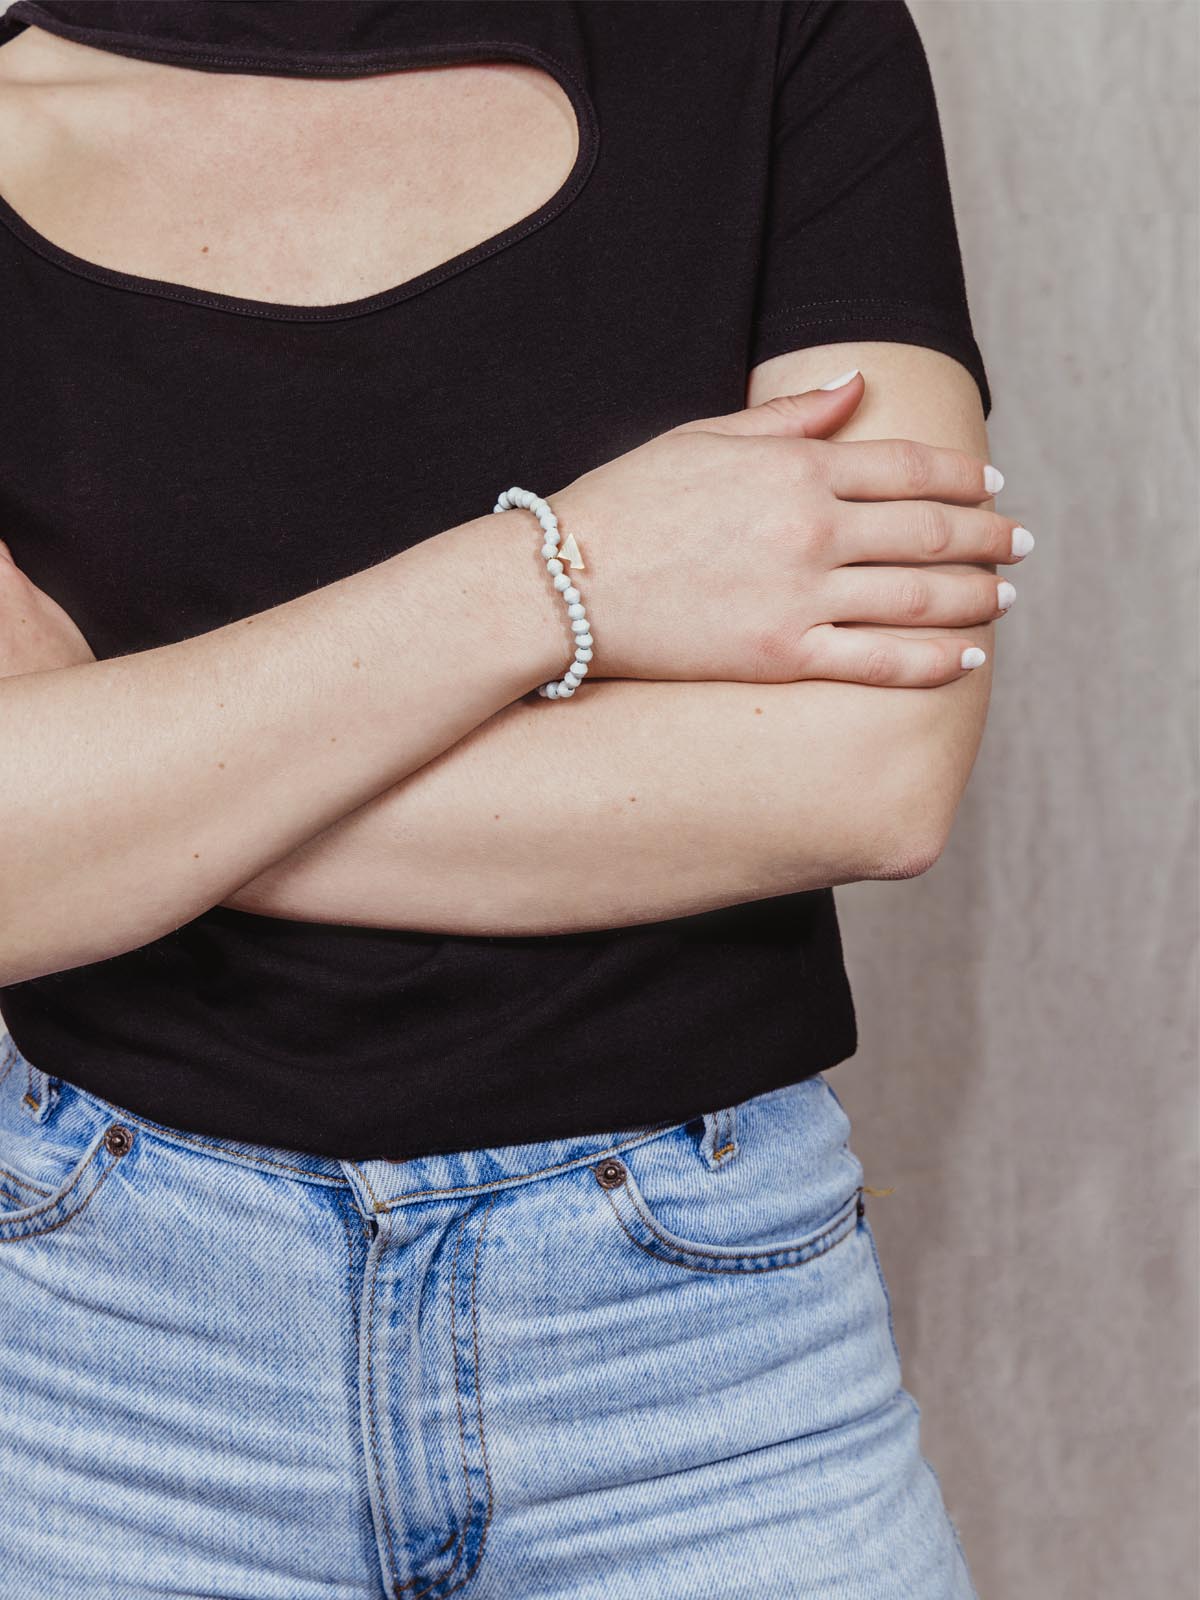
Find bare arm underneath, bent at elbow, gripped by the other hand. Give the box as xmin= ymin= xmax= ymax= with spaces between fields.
xmin=224 ymin=342 xmax=995 ymax=934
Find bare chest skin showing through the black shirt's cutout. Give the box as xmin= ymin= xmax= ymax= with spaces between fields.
xmin=0 ymin=40 xmax=579 ymax=307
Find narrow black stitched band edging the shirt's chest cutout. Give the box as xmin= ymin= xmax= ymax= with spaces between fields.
xmin=0 ymin=40 xmax=600 ymax=322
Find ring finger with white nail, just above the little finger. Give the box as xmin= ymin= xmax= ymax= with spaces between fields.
xmin=821 ymin=566 xmax=1016 ymax=627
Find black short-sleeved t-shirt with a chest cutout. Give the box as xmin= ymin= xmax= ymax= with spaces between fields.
xmin=0 ymin=0 xmax=990 ymax=1158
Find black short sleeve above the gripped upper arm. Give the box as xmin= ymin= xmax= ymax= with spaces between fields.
xmin=749 ymin=0 xmax=992 ymax=416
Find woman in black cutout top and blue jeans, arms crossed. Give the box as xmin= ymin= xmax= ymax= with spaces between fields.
xmin=0 ymin=0 xmax=1032 ymax=1600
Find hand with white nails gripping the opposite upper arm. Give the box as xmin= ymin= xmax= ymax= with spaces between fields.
xmin=549 ymin=376 xmax=1018 ymax=686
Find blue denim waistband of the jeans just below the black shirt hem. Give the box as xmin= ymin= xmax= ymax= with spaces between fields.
xmin=0 ymin=1035 xmax=691 ymax=1211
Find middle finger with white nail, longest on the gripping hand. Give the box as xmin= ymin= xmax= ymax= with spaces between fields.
xmin=834 ymin=501 xmax=1034 ymax=563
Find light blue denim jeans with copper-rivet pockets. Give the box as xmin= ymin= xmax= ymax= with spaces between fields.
xmin=0 ymin=1037 xmax=976 ymax=1600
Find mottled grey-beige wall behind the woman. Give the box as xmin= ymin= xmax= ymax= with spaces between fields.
xmin=830 ymin=0 xmax=1200 ymax=1600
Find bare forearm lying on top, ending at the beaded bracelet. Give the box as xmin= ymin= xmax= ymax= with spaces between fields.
xmin=0 ymin=518 xmax=562 ymax=982
